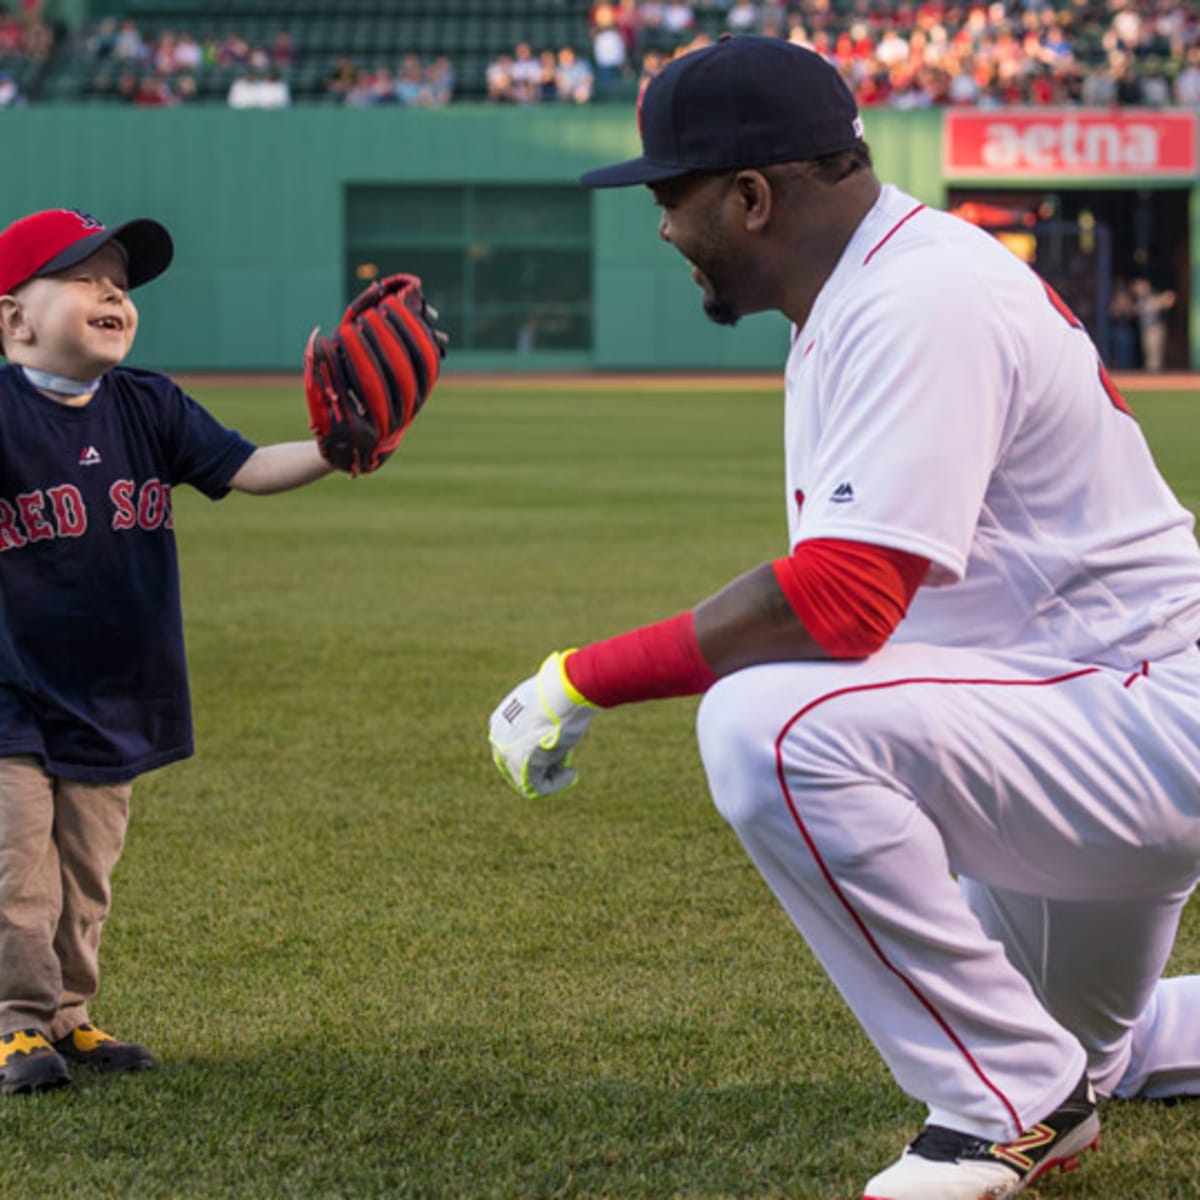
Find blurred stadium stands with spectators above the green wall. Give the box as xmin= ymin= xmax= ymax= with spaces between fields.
xmin=9 ymin=0 xmax=1200 ymax=107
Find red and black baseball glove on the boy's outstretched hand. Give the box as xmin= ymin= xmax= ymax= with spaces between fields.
xmin=304 ymin=275 xmax=446 ymax=475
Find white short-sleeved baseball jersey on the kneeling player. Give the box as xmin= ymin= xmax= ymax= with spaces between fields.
xmin=786 ymin=187 xmax=1200 ymax=666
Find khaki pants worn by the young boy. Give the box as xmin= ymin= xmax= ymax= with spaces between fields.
xmin=0 ymin=756 xmax=132 ymax=1040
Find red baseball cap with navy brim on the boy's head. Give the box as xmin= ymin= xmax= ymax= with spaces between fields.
xmin=0 ymin=209 xmax=175 ymax=295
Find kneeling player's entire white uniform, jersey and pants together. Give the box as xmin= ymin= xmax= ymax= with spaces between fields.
xmin=698 ymin=180 xmax=1200 ymax=1140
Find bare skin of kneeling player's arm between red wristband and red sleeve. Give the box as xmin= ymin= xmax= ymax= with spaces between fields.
xmin=695 ymin=563 xmax=829 ymax=676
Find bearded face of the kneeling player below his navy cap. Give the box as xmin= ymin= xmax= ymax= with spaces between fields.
xmin=653 ymin=172 xmax=751 ymax=325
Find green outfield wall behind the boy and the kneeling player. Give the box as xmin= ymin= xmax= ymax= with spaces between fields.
xmin=0 ymin=106 xmax=1200 ymax=371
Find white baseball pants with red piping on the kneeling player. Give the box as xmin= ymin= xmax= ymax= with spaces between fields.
xmin=697 ymin=644 xmax=1200 ymax=1140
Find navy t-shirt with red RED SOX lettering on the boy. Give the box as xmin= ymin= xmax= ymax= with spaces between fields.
xmin=0 ymin=366 xmax=254 ymax=782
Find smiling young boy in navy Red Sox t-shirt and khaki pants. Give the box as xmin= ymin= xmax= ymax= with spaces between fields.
xmin=0 ymin=209 xmax=332 ymax=1092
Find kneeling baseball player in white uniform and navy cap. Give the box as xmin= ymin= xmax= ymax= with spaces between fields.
xmin=490 ymin=36 xmax=1200 ymax=1200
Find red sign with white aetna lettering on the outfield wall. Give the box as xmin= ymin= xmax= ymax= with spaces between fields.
xmin=942 ymin=108 xmax=1196 ymax=178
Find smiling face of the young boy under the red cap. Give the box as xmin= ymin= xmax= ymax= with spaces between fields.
xmin=20 ymin=242 xmax=138 ymax=379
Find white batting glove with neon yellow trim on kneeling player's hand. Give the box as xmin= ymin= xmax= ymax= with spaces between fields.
xmin=488 ymin=650 xmax=599 ymax=800
